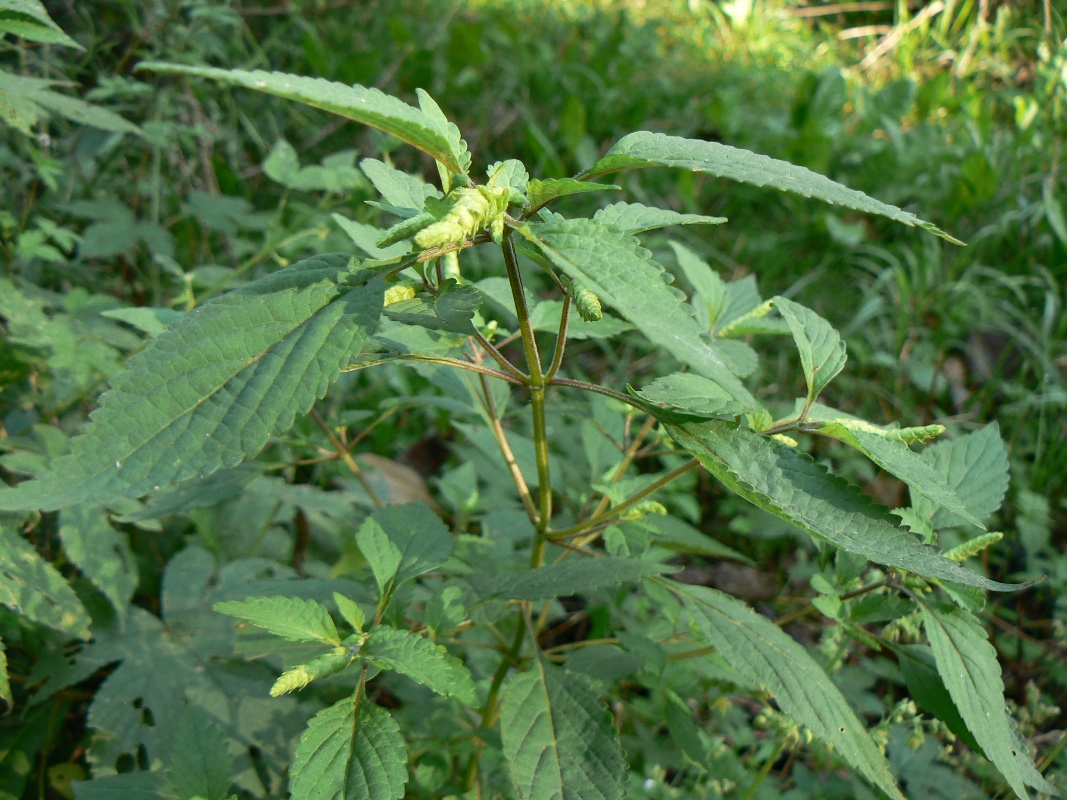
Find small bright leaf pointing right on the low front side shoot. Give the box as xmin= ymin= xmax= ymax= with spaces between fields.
xmin=360 ymin=625 xmax=478 ymax=706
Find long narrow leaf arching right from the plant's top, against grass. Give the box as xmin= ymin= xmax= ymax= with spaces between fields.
xmin=578 ymin=130 xmax=962 ymax=244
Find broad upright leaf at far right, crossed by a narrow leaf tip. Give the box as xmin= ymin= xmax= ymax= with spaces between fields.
xmin=911 ymin=422 xmax=1008 ymax=530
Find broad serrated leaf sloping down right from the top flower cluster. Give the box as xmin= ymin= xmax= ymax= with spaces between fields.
xmin=529 ymin=219 xmax=755 ymax=403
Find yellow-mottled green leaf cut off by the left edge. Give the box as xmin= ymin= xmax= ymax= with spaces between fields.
xmin=0 ymin=528 xmax=90 ymax=639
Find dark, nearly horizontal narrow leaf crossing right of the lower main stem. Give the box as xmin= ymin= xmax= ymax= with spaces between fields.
xmin=476 ymin=556 xmax=678 ymax=601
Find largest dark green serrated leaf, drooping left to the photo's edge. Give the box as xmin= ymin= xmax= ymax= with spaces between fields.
xmin=0 ymin=255 xmax=384 ymax=510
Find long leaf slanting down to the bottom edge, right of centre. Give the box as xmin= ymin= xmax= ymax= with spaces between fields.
xmin=663 ymin=581 xmax=904 ymax=800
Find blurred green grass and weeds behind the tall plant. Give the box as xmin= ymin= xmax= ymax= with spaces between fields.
xmin=0 ymin=0 xmax=1067 ymax=798
